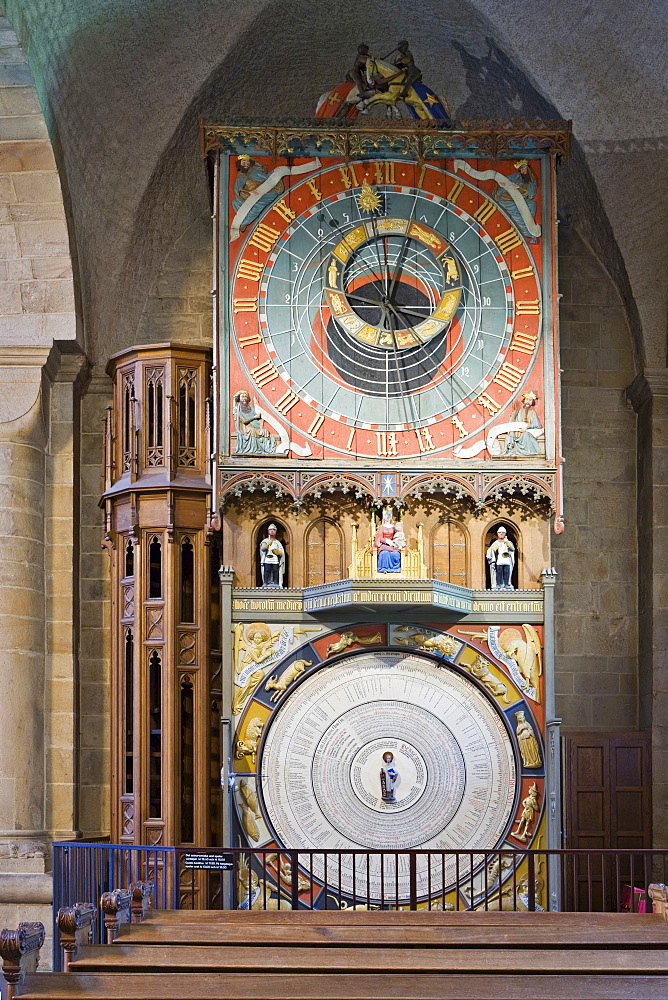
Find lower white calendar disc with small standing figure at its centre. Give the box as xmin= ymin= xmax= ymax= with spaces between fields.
xmin=260 ymin=652 xmax=518 ymax=897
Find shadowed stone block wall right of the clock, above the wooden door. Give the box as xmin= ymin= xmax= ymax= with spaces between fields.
xmin=553 ymin=227 xmax=638 ymax=731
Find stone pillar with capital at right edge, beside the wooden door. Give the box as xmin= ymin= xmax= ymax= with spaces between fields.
xmin=628 ymin=368 xmax=668 ymax=847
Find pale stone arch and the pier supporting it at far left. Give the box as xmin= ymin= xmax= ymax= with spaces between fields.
xmin=0 ymin=11 xmax=76 ymax=948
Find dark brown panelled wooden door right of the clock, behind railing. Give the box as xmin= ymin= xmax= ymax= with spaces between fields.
xmin=564 ymin=733 xmax=652 ymax=910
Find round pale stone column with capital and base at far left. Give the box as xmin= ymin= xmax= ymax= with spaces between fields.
xmin=0 ymin=347 xmax=51 ymax=926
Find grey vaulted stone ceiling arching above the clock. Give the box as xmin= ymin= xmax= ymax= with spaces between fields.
xmin=6 ymin=0 xmax=668 ymax=367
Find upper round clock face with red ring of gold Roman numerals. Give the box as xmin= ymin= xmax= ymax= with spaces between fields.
xmin=230 ymin=161 xmax=541 ymax=458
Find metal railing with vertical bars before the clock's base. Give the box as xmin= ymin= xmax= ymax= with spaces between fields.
xmin=53 ymin=841 xmax=668 ymax=970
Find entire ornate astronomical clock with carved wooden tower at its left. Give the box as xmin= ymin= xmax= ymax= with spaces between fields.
xmin=99 ymin=52 xmax=569 ymax=909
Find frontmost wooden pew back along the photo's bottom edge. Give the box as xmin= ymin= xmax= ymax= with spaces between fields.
xmin=13 ymin=970 xmax=668 ymax=1000
